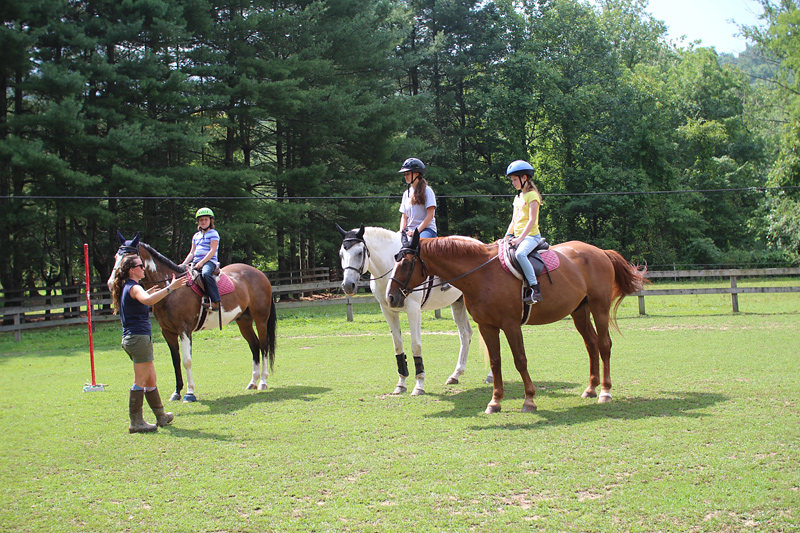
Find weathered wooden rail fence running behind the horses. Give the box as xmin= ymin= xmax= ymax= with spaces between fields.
xmin=0 ymin=268 xmax=800 ymax=341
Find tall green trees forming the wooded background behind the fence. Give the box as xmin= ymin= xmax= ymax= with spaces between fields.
xmin=0 ymin=0 xmax=800 ymax=296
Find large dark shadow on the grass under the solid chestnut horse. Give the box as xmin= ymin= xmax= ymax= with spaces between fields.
xmin=427 ymin=382 xmax=728 ymax=430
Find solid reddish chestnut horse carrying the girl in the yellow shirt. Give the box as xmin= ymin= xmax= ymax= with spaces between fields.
xmin=386 ymin=234 xmax=646 ymax=413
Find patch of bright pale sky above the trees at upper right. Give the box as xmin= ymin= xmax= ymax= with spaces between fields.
xmin=645 ymin=0 xmax=763 ymax=54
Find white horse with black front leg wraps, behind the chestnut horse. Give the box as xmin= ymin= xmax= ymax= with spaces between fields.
xmin=336 ymin=224 xmax=492 ymax=396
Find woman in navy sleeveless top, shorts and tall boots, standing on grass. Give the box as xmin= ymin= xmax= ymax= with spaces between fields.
xmin=111 ymin=255 xmax=188 ymax=433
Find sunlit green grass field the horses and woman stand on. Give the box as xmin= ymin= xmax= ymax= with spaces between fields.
xmin=0 ymin=281 xmax=800 ymax=532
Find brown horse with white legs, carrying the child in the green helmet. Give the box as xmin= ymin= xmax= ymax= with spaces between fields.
xmin=108 ymin=232 xmax=277 ymax=402
